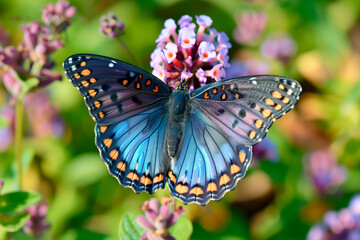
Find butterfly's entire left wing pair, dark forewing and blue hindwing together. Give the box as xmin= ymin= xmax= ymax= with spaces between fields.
xmin=63 ymin=54 xmax=172 ymax=193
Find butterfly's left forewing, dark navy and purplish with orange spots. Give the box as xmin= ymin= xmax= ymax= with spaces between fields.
xmin=64 ymin=54 xmax=171 ymax=125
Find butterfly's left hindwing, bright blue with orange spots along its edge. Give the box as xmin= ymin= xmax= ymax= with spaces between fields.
xmin=95 ymin=105 xmax=168 ymax=193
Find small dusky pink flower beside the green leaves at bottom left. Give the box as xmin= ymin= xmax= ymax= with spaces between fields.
xmin=24 ymin=203 xmax=50 ymax=237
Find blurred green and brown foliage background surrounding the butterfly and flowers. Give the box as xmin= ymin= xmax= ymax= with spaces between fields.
xmin=0 ymin=0 xmax=360 ymax=240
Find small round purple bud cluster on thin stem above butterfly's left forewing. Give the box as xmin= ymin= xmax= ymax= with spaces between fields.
xmin=99 ymin=13 xmax=125 ymax=38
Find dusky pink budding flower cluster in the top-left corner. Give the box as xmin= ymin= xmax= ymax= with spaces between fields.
xmin=0 ymin=0 xmax=75 ymax=97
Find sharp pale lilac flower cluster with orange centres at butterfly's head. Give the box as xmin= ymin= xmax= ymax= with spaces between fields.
xmin=150 ymin=15 xmax=231 ymax=91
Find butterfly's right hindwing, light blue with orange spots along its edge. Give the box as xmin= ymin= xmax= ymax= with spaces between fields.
xmin=167 ymin=108 xmax=252 ymax=205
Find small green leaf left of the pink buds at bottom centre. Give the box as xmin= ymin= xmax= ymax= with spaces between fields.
xmin=119 ymin=214 xmax=145 ymax=240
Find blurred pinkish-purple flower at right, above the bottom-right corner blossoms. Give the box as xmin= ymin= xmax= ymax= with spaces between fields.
xmin=304 ymin=150 xmax=347 ymax=193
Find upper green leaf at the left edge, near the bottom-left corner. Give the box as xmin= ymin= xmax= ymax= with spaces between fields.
xmin=0 ymin=192 xmax=41 ymax=213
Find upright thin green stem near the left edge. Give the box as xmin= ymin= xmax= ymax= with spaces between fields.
xmin=15 ymin=97 xmax=23 ymax=191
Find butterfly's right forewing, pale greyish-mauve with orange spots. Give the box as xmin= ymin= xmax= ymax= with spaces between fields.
xmin=191 ymin=75 xmax=301 ymax=146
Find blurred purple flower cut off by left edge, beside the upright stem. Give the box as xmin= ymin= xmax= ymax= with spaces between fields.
xmin=0 ymin=105 xmax=15 ymax=152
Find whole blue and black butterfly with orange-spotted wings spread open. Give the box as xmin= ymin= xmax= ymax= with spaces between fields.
xmin=63 ymin=54 xmax=301 ymax=205
